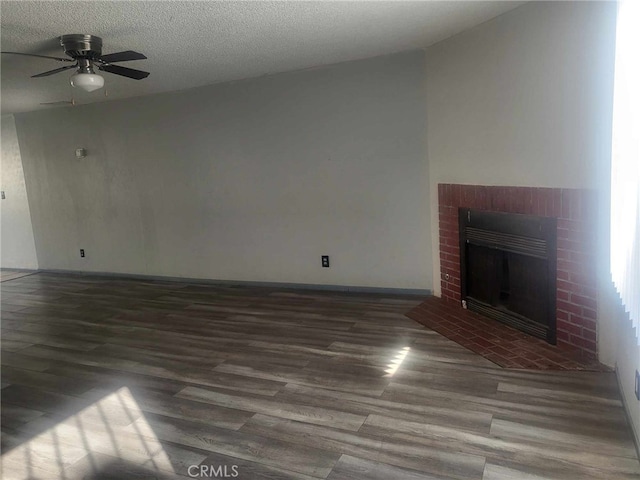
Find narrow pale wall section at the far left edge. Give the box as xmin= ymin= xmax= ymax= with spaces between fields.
xmin=0 ymin=115 xmax=38 ymax=269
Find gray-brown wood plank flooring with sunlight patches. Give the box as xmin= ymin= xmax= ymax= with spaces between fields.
xmin=0 ymin=273 xmax=640 ymax=480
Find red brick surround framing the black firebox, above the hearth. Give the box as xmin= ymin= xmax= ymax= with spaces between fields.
xmin=438 ymin=184 xmax=597 ymax=358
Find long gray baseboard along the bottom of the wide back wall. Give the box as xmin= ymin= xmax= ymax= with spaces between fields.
xmin=38 ymin=269 xmax=431 ymax=296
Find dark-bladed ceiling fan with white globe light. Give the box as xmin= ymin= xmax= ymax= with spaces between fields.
xmin=2 ymin=33 xmax=149 ymax=92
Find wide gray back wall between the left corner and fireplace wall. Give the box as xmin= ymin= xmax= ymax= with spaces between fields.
xmin=16 ymin=52 xmax=432 ymax=289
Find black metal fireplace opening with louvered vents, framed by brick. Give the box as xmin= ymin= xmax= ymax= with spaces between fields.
xmin=458 ymin=208 xmax=556 ymax=344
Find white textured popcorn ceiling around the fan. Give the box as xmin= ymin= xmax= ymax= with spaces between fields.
xmin=0 ymin=0 xmax=523 ymax=113
